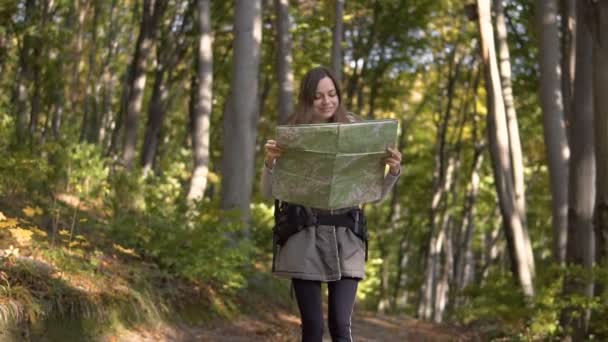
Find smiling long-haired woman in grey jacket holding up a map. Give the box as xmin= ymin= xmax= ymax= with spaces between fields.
xmin=262 ymin=67 xmax=401 ymax=342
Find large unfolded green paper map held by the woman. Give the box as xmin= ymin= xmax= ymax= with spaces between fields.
xmin=272 ymin=120 xmax=398 ymax=209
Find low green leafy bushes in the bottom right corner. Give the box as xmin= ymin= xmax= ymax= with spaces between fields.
xmin=453 ymin=265 xmax=608 ymax=341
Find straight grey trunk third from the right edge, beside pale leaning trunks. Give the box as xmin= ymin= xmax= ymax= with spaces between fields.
xmin=538 ymin=0 xmax=570 ymax=264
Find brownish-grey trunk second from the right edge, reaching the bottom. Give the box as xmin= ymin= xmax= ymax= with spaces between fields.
xmin=562 ymin=1 xmax=592 ymax=341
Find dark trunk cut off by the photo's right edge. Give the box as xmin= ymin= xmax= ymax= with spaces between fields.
xmin=592 ymin=1 xmax=608 ymax=295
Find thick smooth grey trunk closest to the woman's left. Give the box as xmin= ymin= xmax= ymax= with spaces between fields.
xmin=221 ymin=0 xmax=262 ymax=225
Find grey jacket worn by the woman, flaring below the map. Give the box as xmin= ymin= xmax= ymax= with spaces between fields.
xmin=262 ymin=117 xmax=399 ymax=282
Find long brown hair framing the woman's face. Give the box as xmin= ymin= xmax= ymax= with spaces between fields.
xmin=286 ymin=66 xmax=350 ymax=125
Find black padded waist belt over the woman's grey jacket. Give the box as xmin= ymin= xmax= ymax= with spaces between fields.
xmin=274 ymin=200 xmax=368 ymax=261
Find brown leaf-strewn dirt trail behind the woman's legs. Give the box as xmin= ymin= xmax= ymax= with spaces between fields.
xmin=104 ymin=309 xmax=482 ymax=342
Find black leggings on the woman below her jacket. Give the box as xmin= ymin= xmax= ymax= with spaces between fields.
xmin=292 ymin=278 xmax=359 ymax=342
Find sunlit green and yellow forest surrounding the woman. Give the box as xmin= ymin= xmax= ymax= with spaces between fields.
xmin=0 ymin=0 xmax=608 ymax=341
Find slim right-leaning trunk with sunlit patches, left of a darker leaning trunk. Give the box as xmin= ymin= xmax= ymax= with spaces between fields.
xmin=123 ymin=0 xmax=165 ymax=169
